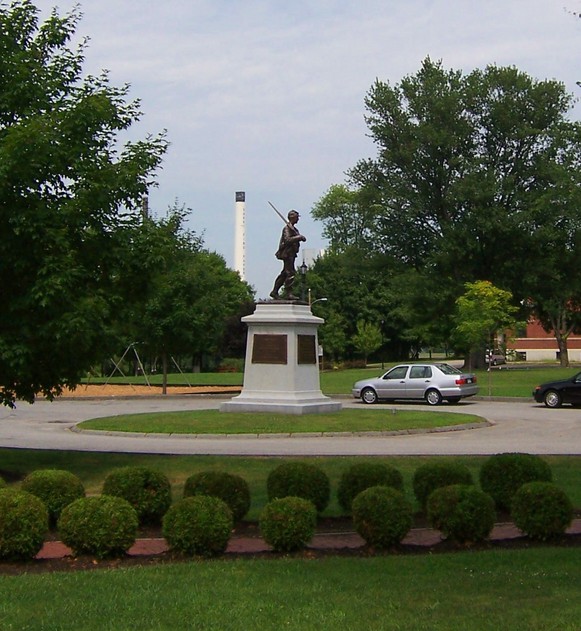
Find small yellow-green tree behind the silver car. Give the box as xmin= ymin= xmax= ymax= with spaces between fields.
xmin=456 ymin=280 xmax=522 ymax=367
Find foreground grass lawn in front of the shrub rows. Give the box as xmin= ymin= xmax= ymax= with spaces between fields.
xmin=0 ymin=547 xmax=581 ymax=631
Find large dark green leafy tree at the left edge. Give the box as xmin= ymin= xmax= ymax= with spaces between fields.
xmin=0 ymin=0 xmax=167 ymax=405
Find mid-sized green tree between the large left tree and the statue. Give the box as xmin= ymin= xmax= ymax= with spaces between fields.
xmin=119 ymin=205 xmax=253 ymax=393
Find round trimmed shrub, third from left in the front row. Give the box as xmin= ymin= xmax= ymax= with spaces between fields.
xmin=162 ymin=495 xmax=234 ymax=556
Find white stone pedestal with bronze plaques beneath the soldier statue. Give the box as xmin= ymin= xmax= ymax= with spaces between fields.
xmin=220 ymin=301 xmax=342 ymax=414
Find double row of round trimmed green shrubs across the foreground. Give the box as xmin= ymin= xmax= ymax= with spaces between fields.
xmin=0 ymin=454 xmax=573 ymax=558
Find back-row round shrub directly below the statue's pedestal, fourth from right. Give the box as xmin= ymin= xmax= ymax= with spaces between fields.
xmin=266 ymin=462 xmax=331 ymax=513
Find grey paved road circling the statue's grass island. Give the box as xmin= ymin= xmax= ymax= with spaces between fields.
xmin=0 ymin=396 xmax=581 ymax=456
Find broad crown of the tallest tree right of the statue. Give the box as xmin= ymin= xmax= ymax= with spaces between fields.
xmin=351 ymin=59 xmax=574 ymax=288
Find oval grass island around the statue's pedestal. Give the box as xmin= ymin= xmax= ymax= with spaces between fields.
xmin=79 ymin=408 xmax=484 ymax=434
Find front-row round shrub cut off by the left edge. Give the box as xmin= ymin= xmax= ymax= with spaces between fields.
xmin=0 ymin=488 xmax=48 ymax=560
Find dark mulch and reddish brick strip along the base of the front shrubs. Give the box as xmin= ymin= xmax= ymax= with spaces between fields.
xmin=0 ymin=518 xmax=581 ymax=575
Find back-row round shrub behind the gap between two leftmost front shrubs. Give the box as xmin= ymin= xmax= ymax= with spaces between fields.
xmin=21 ymin=469 xmax=85 ymax=526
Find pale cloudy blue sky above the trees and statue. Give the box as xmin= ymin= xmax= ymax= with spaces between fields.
xmin=34 ymin=0 xmax=581 ymax=299
